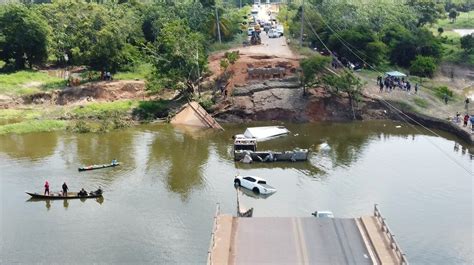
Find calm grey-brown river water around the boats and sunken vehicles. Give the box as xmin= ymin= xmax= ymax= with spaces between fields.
xmin=0 ymin=122 xmax=473 ymax=264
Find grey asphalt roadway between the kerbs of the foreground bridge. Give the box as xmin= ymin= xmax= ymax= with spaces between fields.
xmin=231 ymin=217 xmax=372 ymax=264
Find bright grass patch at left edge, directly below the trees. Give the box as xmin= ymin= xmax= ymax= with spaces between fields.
xmin=0 ymin=71 xmax=65 ymax=96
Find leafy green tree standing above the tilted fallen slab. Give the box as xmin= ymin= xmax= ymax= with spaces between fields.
xmin=148 ymin=20 xmax=207 ymax=93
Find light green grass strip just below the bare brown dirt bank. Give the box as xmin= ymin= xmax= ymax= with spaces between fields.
xmin=72 ymin=100 xmax=138 ymax=118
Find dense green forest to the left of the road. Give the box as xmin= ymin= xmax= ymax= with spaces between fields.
xmin=0 ymin=0 xmax=256 ymax=92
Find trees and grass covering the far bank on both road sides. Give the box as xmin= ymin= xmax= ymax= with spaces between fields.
xmin=0 ymin=0 xmax=474 ymax=143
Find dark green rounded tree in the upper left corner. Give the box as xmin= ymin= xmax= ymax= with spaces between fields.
xmin=0 ymin=4 xmax=50 ymax=69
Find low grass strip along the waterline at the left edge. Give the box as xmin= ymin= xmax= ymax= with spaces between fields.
xmin=0 ymin=120 xmax=67 ymax=135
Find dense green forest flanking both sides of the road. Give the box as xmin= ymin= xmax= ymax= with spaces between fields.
xmin=0 ymin=0 xmax=474 ymax=88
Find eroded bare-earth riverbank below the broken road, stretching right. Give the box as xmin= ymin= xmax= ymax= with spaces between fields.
xmin=214 ymin=80 xmax=474 ymax=144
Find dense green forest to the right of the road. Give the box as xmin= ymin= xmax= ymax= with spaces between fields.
xmin=279 ymin=0 xmax=474 ymax=77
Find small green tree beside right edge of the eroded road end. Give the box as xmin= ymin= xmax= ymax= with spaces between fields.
xmin=300 ymin=54 xmax=331 ymax=94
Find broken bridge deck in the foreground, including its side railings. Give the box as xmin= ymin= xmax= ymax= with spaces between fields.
xmin=208 ymin=205 xmax=408 ymax=264
